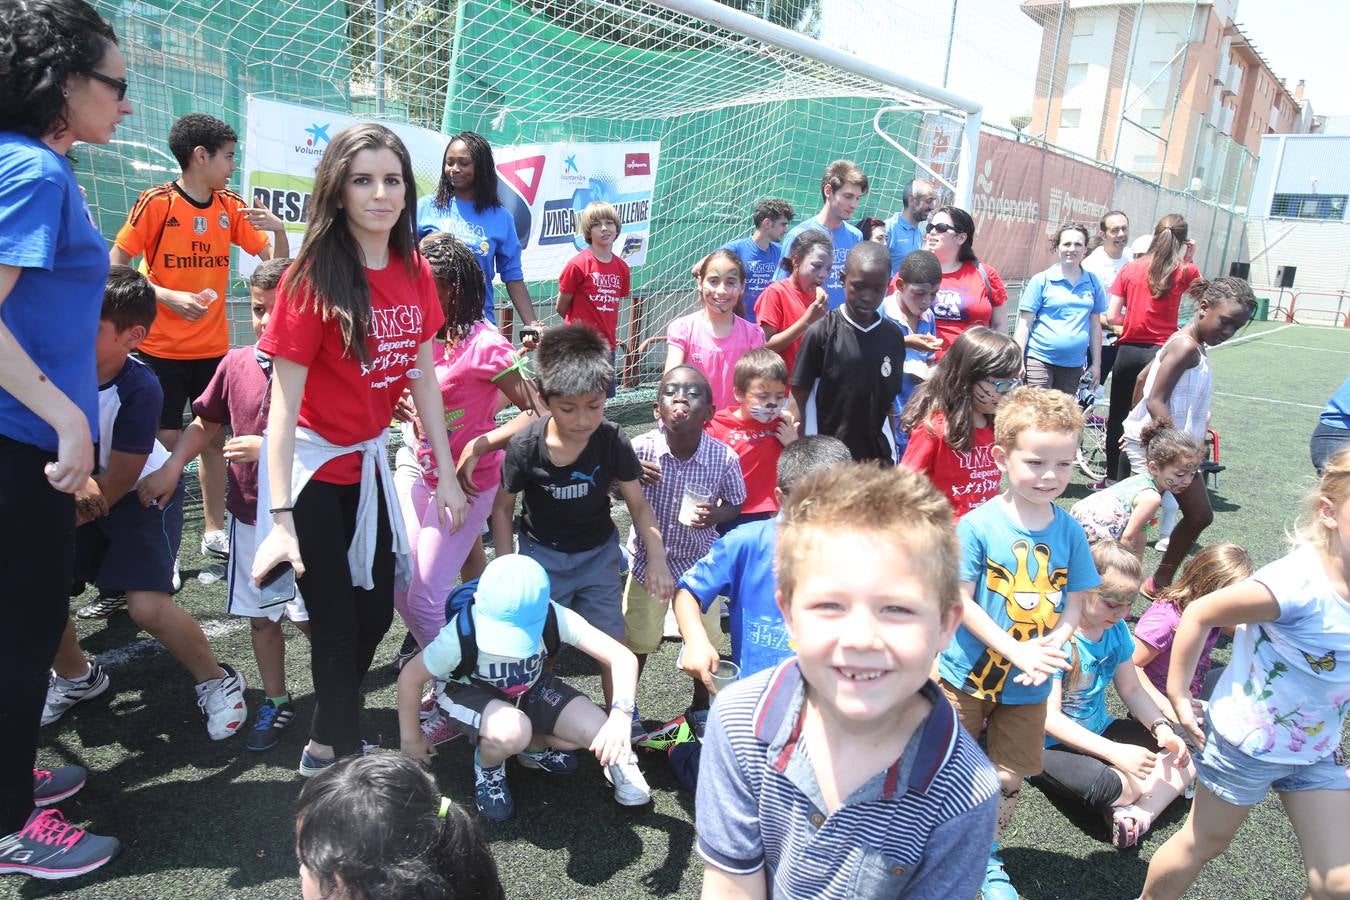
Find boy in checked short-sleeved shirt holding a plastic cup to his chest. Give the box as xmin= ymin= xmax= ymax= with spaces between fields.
xmin=624 ymin=366 xmax=745 ymax=739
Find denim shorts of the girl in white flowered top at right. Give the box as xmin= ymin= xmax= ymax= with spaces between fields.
xmin=1195 ymin=727 xmax=1350 ymax=807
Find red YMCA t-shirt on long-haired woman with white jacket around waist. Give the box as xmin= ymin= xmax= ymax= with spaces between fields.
xmin=258 ymin=255 xmax=446 ymax=484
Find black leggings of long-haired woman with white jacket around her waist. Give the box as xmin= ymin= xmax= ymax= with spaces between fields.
xmin=295 ymin=480 xmax=394 ymax=755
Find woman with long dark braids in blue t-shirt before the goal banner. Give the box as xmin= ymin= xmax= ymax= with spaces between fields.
xmin=417 ymin=131 xmax=539 ymax=333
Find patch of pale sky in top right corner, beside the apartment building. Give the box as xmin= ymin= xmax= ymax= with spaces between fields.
xmin=1234 ymin=0 xmax=1350 ymax=116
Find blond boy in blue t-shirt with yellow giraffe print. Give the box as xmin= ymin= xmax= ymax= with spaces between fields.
xmin=938 ymin=387 xmax=1102 ymax=900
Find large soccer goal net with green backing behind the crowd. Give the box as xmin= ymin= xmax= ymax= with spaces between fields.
xmin=87 ymin=0 xmax=965 ymax=376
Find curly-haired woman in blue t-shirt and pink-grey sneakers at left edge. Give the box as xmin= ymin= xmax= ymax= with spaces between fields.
xmin=0 ymin=0 xmax=131 ymax=878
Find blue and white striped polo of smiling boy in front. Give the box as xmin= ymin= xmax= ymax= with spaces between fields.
xmin=695 ymin=658 xmax=998 ymax=900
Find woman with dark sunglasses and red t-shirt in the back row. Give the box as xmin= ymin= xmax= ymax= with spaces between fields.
xmin=923 ymin=206 xmax=1008 ymax=359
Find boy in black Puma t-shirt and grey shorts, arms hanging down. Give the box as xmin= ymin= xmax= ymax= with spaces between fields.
xmin=491 ymin=319 xmax=675 ymax=714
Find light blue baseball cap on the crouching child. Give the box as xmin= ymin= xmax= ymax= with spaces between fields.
xmin=470 ymin=553 xmax=549 ymax=660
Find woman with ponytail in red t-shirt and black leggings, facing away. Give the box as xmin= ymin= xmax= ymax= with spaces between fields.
xmin=1094 ymin=213 xmax=1200 ymax=490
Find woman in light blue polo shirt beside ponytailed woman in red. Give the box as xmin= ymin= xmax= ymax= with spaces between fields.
xmin=1014 ymin=225 xmax=1107 ymax=395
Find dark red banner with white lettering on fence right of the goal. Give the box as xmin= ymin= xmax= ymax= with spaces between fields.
xmin=969 ymin=134 xmax=1115 ymax=282
